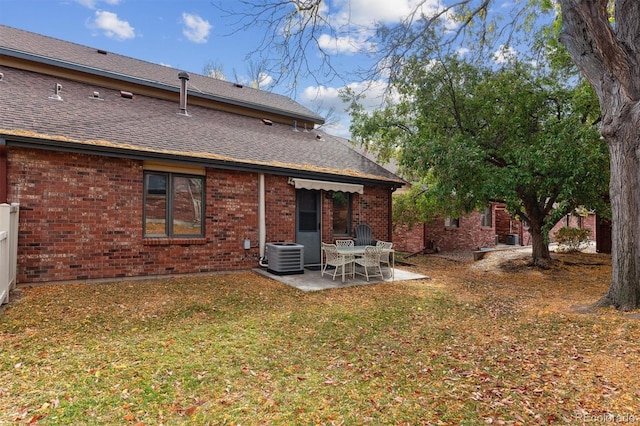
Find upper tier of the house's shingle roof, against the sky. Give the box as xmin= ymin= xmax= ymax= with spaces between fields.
xmin=0 ymin=25 xmax=324 ymax=124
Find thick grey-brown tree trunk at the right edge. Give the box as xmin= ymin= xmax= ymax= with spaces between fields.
xmin=560 ymin=0 xmax=640 ymax=310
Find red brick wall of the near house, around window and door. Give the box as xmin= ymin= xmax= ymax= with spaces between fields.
xmin=8 ymin=147 xmax=390 ymax=283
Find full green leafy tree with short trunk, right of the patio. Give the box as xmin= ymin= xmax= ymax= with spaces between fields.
xmin=352 ymin=56 xmax=608 ymax=262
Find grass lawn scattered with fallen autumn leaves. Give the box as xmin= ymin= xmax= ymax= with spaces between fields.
xmin=0 ymin=253 xmax=640 ymax=425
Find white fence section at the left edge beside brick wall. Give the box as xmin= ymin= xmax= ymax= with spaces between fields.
xmin=0 ymin=203 xmax=20 ymax=304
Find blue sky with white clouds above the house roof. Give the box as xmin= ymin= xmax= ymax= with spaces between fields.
xmin=0 ymin=0 xmax=528 ymax=138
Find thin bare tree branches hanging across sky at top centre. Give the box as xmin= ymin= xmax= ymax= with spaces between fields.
xmin=215 ymin=0 xmax=530 ymax=91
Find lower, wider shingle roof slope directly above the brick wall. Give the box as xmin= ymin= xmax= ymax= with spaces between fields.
xmin=0 ymin=66 xmax=402 ymax=186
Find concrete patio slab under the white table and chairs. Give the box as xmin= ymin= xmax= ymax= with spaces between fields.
xmin=254 ymin=268 xmax=429 ymax=291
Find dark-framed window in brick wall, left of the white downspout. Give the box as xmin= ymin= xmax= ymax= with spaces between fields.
xmin=144 ymin=171 xmax=204 ymax=237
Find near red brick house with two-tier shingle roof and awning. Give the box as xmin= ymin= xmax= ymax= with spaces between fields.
xmin=0 ymin=26 xmax=403 ymax=283
